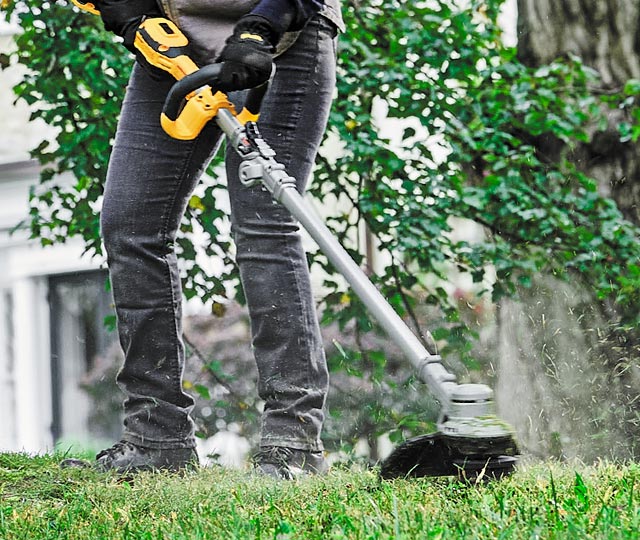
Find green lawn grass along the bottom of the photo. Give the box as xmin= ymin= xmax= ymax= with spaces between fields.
xmin=0 ymin=454 xmax=640 ymax=540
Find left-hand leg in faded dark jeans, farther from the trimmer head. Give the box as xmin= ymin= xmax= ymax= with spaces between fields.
xmin=96 ymin=65 xmax=220 ymax=468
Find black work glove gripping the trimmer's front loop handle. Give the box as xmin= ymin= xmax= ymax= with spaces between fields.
xmin=216 ymin=14 xmax=280 ymax=92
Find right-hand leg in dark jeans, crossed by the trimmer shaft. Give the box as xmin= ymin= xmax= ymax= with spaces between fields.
xmin=227 ymin=13 xmax=335 ymax=472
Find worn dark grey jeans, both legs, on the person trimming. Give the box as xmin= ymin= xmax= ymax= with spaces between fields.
xmin=101 ymin=16 xmax=336 ymax=450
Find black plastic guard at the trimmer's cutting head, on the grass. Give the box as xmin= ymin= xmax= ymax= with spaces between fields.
xmin=380 ymin=432 xmax=518 ymax=482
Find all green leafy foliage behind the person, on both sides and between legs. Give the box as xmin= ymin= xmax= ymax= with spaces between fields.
xmin=3 ymin=0 xmax=640 ymax=450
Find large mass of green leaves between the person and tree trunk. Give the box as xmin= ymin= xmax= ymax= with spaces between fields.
xmin=312 ymin=2 xmax=639 ymax=344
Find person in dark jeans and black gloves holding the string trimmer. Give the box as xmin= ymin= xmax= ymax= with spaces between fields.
xmin=64 ymin=0 xmax=342 ymax=479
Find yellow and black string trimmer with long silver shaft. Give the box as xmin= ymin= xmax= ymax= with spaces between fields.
xmin=74 ymin=0 xmax=518 ymax=479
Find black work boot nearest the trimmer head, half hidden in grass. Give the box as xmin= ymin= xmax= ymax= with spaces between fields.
xmin=253 ymin=446 xmax=329 ymax=480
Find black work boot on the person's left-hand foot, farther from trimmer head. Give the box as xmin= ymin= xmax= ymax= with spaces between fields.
xmin=60 ymin=441 xmax=198 ymax=474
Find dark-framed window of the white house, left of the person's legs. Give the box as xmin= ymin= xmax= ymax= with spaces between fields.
xmin=49 ymin=271 xmax=122 ymax=449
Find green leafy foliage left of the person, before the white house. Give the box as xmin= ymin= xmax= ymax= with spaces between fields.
xmin=0 ymin=1 xmax=130 ymax=254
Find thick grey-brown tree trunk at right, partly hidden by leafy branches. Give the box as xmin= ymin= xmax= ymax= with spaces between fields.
xmin=496 ymin=0 xmax=640 ymax=461
